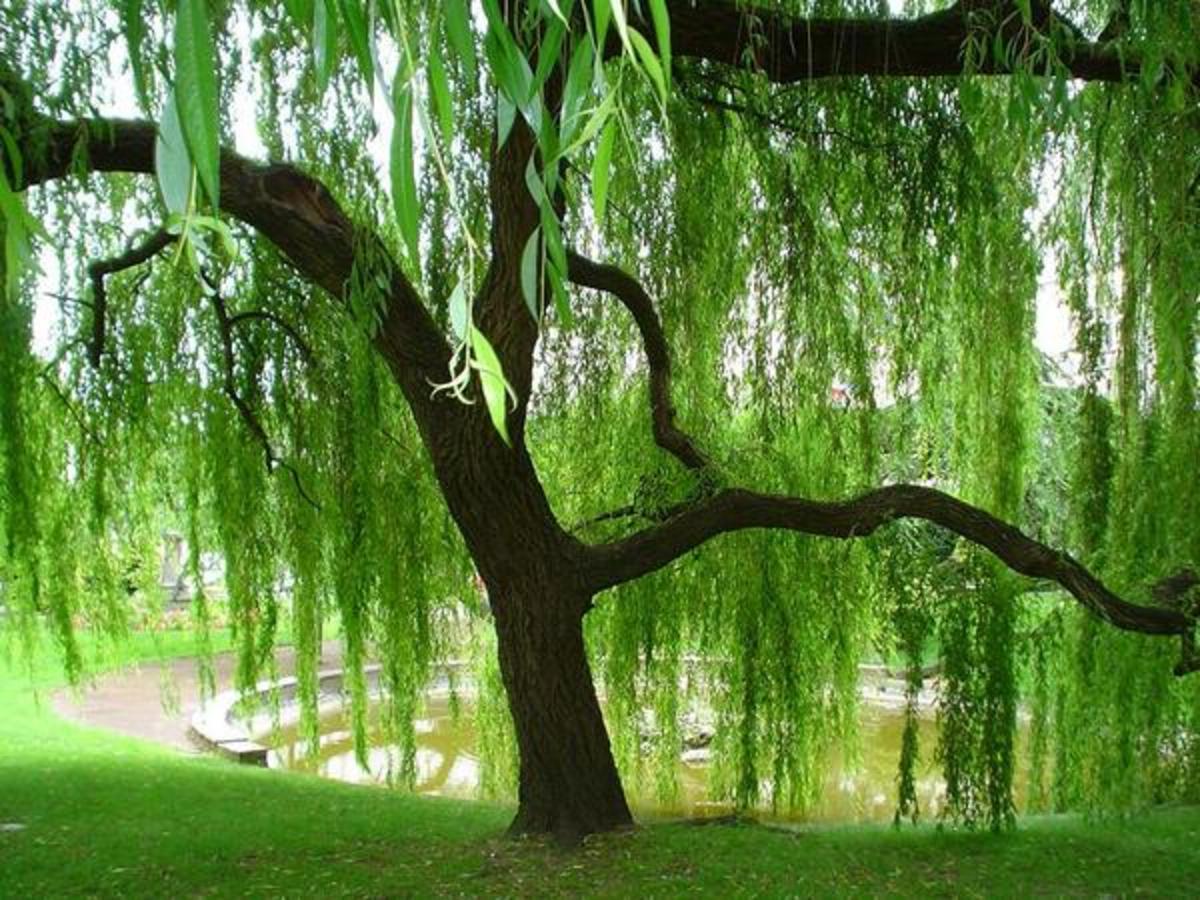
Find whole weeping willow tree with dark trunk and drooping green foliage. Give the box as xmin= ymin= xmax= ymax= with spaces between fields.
xmin=0 ymin=0 xmax=1200 ymax=834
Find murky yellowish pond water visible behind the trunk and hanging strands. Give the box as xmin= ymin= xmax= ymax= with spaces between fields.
xmin=269 ymin=681 xmax=1021 ymax=823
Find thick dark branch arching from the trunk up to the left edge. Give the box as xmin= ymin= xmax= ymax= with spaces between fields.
xmin=17 ymin=119 xmax=450 ymax=406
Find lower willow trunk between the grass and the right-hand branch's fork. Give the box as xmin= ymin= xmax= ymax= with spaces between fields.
xmin=492 ymin=576 xmax=632 ymax=842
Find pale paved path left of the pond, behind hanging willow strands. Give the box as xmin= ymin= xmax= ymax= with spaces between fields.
xmin=53 ymin=641 xmax=342 ymax=754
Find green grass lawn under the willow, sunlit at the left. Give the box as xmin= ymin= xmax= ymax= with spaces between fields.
xmin=0 ymin=637 xmax=1200 ymax=898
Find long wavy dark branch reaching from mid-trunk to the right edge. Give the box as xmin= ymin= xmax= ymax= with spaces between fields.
xmin=576 ymin=485 xmax=1200 ymax=674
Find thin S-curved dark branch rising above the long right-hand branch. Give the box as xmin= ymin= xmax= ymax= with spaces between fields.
xmin=566 ymin=251 xmax=708 ymax=469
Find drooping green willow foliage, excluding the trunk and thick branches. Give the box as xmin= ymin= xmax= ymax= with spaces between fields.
xmin=0 ymin=0 xmax=1200 ymax=828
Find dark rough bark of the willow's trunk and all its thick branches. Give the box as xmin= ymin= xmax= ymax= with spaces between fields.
xmin=0 ymin=0 xmax=1198 ymax=839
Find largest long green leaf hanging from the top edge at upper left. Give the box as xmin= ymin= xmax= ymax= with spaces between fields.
xmin=175 ymin=0 xmax=221 ymax=209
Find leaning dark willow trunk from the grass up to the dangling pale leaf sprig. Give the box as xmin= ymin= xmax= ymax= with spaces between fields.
xmin=418 ymin=415 xmax=632 ymax=842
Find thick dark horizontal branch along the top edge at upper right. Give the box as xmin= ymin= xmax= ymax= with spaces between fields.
xmin=628 ymin=0 xmax=1138 ymax=83
